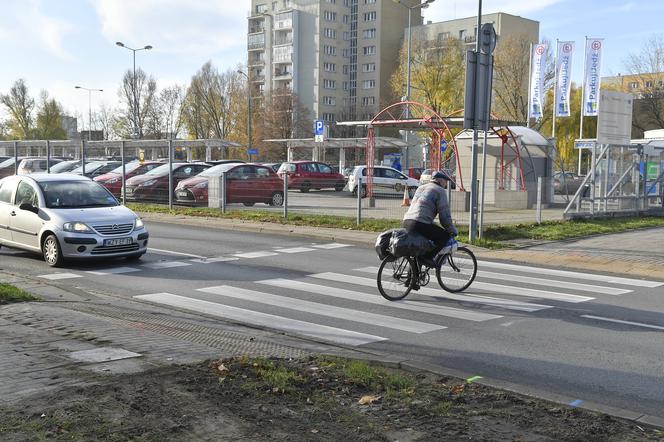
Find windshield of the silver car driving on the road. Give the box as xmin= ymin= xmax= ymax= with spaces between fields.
xmin=39 ymin=181 xmax=119 ymax=209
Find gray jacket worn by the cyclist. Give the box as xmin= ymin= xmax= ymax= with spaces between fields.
xmin=403 ymin=183 xmax=459 ymax=235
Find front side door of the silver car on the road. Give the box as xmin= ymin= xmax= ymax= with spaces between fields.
xmin=9 ymin=180 xmax=44 ymax=250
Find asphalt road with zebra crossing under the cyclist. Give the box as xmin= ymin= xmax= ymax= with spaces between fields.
xmin=0 ymin=223 xmax=664 ymax=418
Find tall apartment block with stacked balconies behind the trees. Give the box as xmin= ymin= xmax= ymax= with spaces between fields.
xmin=247 ymin=0 xmax=422 ymax=133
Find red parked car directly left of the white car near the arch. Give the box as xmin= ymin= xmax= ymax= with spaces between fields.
xmin=277 ymin=161 xmax=346 ymax=192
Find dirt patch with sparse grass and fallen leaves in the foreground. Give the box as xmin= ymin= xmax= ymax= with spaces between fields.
xmin=0 ymin=357 xmax=664 ymax=441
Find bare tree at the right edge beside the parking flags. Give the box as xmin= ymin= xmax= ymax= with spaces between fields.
xmin=625 ymin=34 xmax=664 ymax=135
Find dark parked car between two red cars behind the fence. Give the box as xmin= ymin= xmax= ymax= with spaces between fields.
xmin=125 ymin=163 xmax=211 ymax=203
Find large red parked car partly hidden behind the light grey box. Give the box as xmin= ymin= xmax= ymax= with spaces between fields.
xmin=175 ymin=163 xmax=284 ymax=206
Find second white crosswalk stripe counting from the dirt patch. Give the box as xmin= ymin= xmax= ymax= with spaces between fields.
xmin=198 ymin=285 xmax=447 ymax=333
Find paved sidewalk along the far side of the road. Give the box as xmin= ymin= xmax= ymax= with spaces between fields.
xmin=141 ymin=213 xmax=664 ymax=280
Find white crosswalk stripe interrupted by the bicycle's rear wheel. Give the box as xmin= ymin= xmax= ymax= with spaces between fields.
xmin=320 ymin=267 xmax=552 ymax=312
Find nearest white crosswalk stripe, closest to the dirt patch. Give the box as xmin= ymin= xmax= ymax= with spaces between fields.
xmin=134 ymin=293 xmax=387 ymax=346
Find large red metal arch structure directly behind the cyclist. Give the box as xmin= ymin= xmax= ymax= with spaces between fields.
xmin=367 ymin=101 xmax=465 ymax=196
